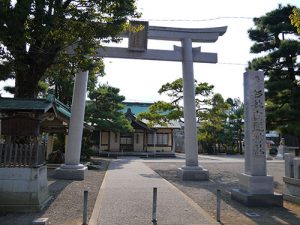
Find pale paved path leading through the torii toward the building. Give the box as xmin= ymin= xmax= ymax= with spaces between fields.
xmin=89 ymin=158 xmax=218 ymax=225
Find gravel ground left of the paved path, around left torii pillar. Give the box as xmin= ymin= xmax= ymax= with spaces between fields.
xmin=0 ymin=159 xmax=109 ymax=225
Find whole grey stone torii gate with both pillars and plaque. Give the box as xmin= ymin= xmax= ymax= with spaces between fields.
xmin=56 ymin=21 xmax=227 ymax=180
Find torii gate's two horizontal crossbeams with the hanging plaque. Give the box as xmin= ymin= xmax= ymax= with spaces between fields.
xmin=96 ymin=21 xmax=227 ymax=63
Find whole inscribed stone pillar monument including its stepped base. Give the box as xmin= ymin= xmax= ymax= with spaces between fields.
xmin=231 ymin=71 xmax=282 ymax=206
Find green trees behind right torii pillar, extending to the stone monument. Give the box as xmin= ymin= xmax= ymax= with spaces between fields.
xmin=138 ymin=79 xmax=244 ymax=153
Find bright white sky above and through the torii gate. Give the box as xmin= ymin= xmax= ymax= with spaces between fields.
xmin=0 ymin=0 xmax=300 ymax=102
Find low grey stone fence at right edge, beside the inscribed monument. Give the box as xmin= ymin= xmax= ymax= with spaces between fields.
xmin=283 ymin=153 xmax=300 ymax=204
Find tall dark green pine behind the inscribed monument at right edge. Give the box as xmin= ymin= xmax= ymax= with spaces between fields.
xmin=248 ymin=5 xmax=300 ymax=146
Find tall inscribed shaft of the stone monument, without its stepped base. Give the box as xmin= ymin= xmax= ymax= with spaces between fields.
xmin=244 ymin=71 xmax=266 ymax=174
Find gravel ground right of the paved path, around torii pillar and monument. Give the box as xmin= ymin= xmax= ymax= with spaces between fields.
xmin=147 ymin=161 xmax=300 ymax=225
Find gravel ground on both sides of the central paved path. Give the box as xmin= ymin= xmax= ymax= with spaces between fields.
xmin=0 ymin=159 xmax=300 ymax=225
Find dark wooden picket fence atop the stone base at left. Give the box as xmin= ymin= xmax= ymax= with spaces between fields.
xmin=0 ymin=144 xmax=46 ymax=167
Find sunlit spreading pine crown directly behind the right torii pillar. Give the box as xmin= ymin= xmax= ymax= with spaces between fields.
xmin=138 ymin=78 xmax=213 ymax=125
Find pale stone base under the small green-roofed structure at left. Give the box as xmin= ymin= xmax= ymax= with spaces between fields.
xmin=0 ymin=166 xmax=50 ymax=212
